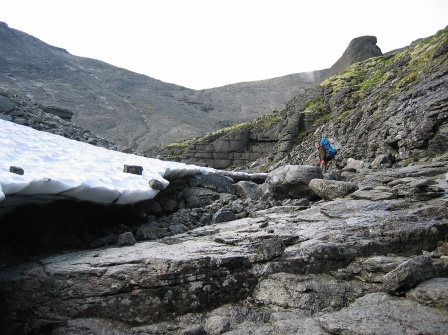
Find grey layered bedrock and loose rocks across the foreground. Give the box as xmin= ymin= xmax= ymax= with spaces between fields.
xmin=0 ymin=157 xmax=448 ymax=335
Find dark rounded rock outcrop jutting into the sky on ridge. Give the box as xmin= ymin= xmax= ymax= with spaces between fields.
xmin=328 ymin=36 xmax=383 ymax=77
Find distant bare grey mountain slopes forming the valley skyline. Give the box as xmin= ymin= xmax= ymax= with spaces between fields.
xmin=0 ymin=23 xmax=327 ymax=152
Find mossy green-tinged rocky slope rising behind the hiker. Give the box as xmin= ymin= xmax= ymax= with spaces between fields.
xmin=163 ymin=29 xmax=448 ymax=171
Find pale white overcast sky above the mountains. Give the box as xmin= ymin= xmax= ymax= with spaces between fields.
xmin=0 ymin=0 xmax=448 ymax=89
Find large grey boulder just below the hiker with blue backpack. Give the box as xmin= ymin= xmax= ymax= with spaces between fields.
xmin=257 ymin=165 xmax=323 ymax=199
